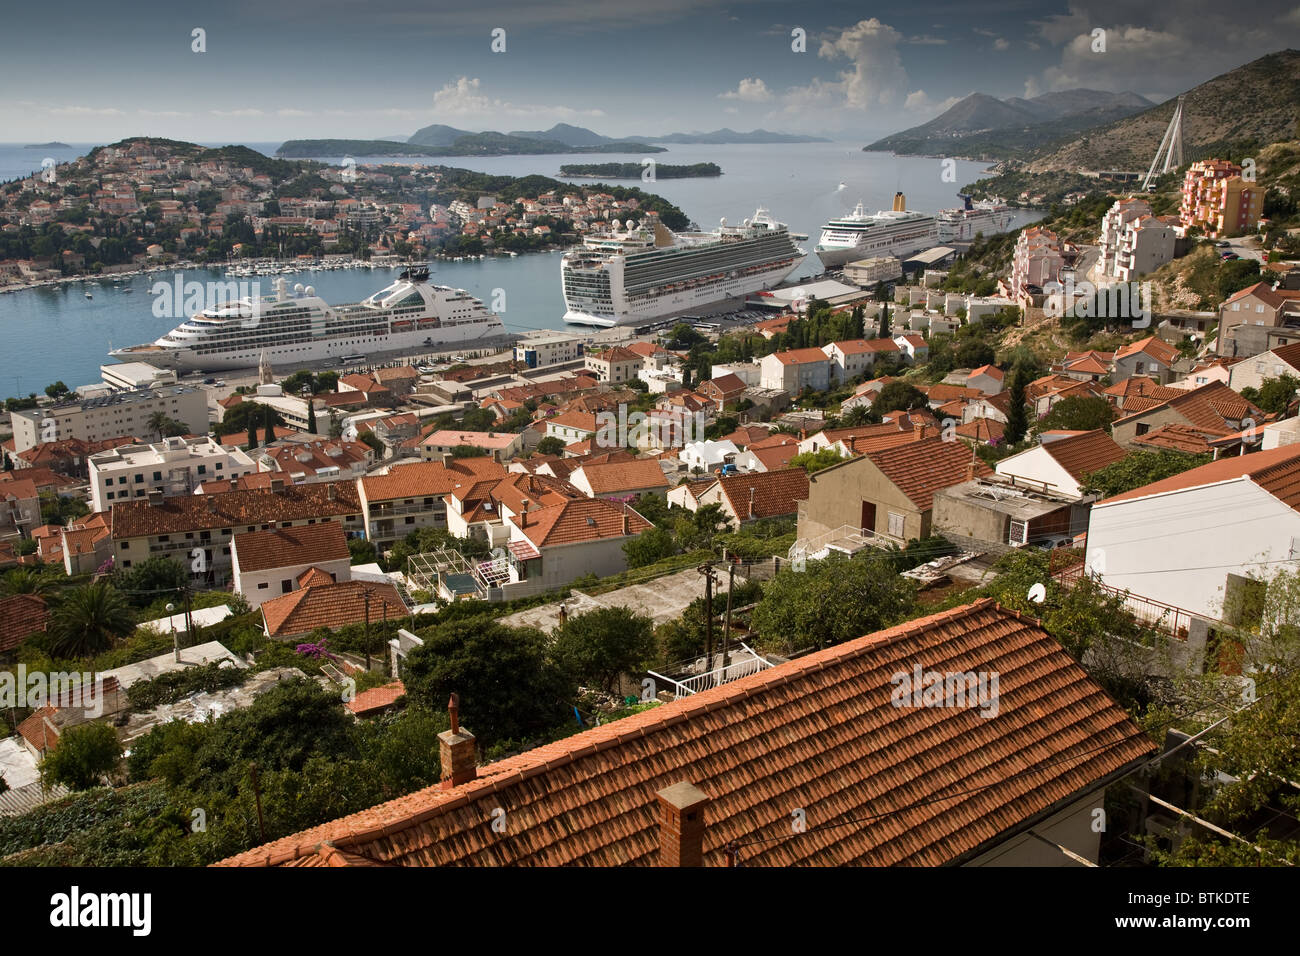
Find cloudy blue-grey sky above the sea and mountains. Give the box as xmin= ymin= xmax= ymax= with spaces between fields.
xmin=0 ymin=0 xmax=1300 ymax=143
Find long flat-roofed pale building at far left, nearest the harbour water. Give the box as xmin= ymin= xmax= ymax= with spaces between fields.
xmin=12 ymin=385 xmax=208 ymax=451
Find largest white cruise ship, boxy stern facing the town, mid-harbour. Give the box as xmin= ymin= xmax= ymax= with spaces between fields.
xmin=560 ymin=208 xmax=807 ymax=328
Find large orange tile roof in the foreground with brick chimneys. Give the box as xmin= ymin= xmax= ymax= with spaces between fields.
xmin=221 ymin=600 xmax=1157 ymax=866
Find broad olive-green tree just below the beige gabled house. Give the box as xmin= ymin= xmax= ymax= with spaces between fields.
xmin=753 ymin=549 xmax=917 ymax=652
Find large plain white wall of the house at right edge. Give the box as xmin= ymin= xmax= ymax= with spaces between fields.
xmin=1087 ymin=479 xmax=1300 ymax=618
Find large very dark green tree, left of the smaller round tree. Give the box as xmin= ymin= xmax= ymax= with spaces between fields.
xmin=403 ymin=618 xmax=577 ymax=747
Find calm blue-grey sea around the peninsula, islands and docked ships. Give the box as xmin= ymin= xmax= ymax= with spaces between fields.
xmin=0 ymin=142 xmax=1039 ymax=397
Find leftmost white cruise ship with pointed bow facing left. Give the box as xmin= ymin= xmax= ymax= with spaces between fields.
xmin=109 ymin=269 xmax=506 ymax=372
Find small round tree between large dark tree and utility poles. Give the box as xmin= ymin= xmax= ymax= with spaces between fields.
xmin=551 ymin=607 xmax=655 ymax=693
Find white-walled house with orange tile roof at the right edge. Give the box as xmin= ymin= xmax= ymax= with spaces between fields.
xmin=1086 ymin=445 xmax=1300 ymax=627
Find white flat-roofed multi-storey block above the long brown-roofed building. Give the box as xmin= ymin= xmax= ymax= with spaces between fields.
xmin=86 ymin=437 xmax=257 ymax=511
